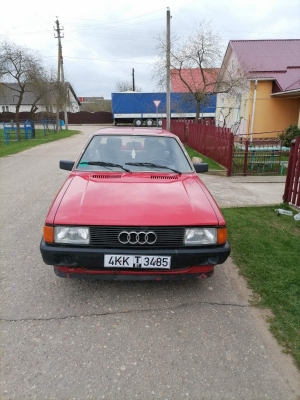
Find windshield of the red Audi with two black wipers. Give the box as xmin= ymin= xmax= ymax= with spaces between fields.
xmin=76 ymin=135 xmax=192 ymax=173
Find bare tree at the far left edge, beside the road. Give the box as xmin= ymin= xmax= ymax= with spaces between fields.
xmin=0 ymin=41 xmax=52 ymax=140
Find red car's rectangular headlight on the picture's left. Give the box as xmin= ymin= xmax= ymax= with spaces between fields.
xmin=54 ymin=226 xmax=90 ymax=244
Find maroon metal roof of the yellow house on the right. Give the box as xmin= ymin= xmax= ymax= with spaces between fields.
xmin=229 ymin=39 xmax=300 ymax=91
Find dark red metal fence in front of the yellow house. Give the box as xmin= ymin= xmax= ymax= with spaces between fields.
xmin=163 ymin=120 xmax=290 ymax=176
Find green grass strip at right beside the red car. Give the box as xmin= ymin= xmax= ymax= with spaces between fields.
xmin=222 ymin=205 xmax=300 ymax=369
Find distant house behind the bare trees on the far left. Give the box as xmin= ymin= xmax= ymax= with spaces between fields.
xmin=0 ymin=83 xmax=80 ymax=113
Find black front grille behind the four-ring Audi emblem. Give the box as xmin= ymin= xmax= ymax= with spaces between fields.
xmin=90 ymin=226 xmax=184 ymax=249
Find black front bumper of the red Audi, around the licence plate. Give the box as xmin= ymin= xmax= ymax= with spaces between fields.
xmin=40 ymin=239 xmax=230 ymax=279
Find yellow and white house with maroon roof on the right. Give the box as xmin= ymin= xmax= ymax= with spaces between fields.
xmin=216 ymin=39 xmax=300 ymax=137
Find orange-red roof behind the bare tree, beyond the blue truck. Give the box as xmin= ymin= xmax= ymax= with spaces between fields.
xmin=171 ymin=68 xmax=220 ymax=93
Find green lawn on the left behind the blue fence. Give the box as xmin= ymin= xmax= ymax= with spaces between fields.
xmin=0 ymin=129 xmax=80 ymax=157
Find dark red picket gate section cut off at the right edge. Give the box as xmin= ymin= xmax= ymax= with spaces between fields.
xmin=283 ymin=136 xmax=300 ymax=207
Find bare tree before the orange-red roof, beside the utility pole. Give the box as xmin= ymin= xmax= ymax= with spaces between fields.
xmin=154 ymin=21 xmax=245 ymax=122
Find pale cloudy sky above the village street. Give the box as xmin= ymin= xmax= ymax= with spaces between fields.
xmin=0 ymin=0 xmax=300 ymax=99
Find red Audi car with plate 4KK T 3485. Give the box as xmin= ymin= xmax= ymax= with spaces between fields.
xmin=40 ymin=127 xmax=230 ymax=280
